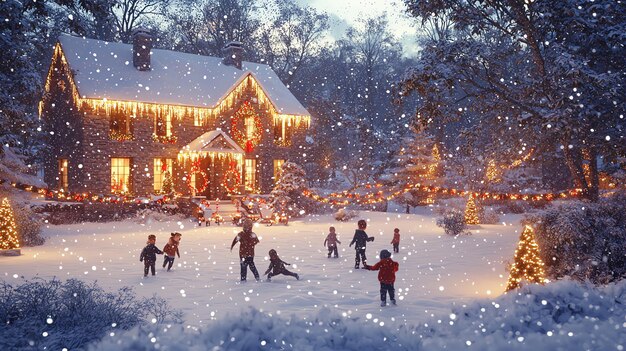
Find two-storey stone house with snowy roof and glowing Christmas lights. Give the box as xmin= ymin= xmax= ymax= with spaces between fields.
xmin=39 ymin=30 xmax=310 ymax=199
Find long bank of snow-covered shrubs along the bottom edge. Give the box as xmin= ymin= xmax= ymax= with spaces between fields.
xmin=93 ymin=281 xmax=626 ymax=351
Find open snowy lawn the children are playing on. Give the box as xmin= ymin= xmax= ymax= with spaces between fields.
xmin=0 ymin=208 xmax=522 ymax=326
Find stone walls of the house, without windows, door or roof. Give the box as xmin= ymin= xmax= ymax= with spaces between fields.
xmin=42 ymin=56 xmax=305 ymax=198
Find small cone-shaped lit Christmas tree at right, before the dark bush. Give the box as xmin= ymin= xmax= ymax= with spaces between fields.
xmin=506 ymin=225 xmax=546 ymax=291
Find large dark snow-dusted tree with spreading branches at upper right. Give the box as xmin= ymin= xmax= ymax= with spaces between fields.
xmin=399 ymin=0 xmax=626 ymax=199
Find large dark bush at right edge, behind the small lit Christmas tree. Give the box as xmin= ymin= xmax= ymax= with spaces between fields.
xmin=526 ymin=193 xmax=626 ymax=284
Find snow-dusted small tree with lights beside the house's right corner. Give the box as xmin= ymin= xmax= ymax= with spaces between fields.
xmin=270 ymin=162 xmax=308 ymax=217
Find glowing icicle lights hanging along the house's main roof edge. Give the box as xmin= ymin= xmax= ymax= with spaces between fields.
xmin=39 ymin=43 xmax=311 ymax=132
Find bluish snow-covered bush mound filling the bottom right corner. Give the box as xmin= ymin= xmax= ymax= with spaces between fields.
xmin=415 ymin=281 xmax=626 ymax=351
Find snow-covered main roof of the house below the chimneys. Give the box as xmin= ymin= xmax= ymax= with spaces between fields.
xmin=59 ymin=34 xmax=310 ymax=116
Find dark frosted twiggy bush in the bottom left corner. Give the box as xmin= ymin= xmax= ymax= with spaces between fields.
xmin=0 ymin=279 xmax=182 ymax=350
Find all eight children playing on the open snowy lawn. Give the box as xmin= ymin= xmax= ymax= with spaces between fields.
xmin=139 ymin=219 xmax=400 ymax=306
